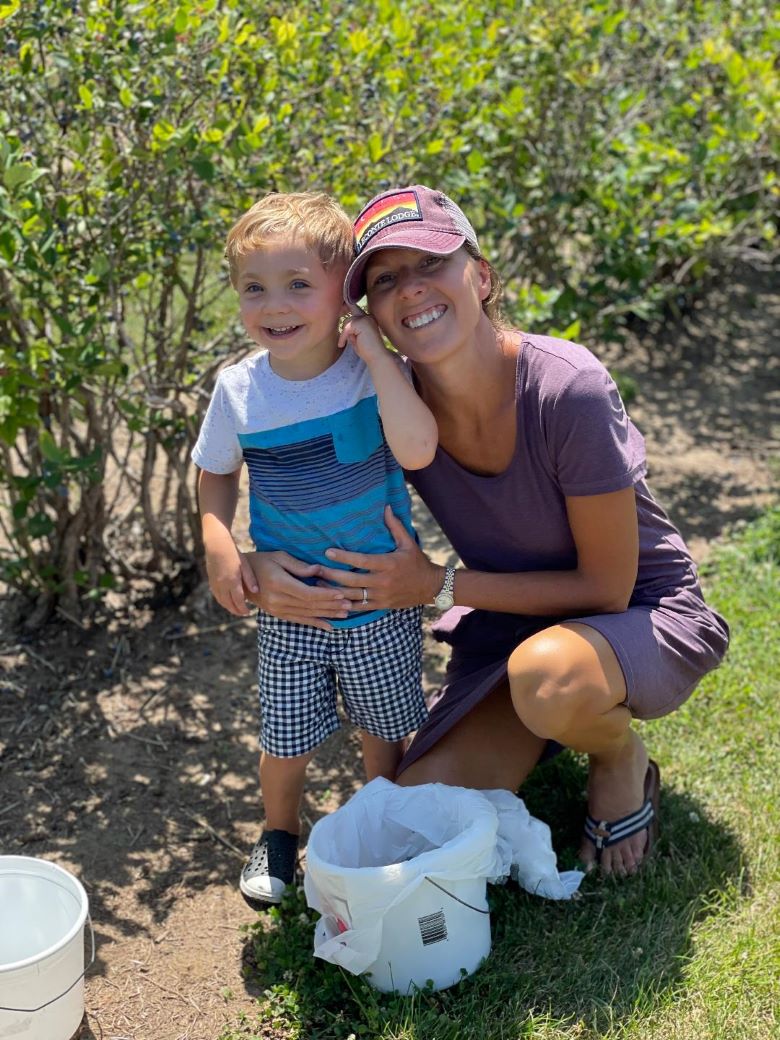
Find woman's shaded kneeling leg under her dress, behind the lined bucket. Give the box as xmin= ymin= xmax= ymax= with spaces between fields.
xmin=397 ymin=682 xmax=546 ymax=791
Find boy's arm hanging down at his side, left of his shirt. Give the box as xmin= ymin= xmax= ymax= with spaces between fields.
xmin=198 ymin=467 xmax=258 ymax=617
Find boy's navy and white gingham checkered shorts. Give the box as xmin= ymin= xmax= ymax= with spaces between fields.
xmin=257 ymin=606 xmax=427 ymax=758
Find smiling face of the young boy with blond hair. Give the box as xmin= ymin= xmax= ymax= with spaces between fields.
xmin=236 ymin=236 xmax=346 ymax=380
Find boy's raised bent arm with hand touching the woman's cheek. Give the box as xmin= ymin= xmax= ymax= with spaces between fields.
xmin=339 ymin=314 xmax=439 ymax=469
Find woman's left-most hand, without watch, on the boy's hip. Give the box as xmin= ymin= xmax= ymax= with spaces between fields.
xmin=242 ymin=551 xmax=352 ymax=632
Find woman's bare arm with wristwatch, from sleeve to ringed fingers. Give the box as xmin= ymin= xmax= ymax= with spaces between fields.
xmin=320 ymin=487 xmax=639 ymax=616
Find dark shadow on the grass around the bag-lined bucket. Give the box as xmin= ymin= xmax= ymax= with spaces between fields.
xmin=244 ymin=754 xmax=744 ymax=1040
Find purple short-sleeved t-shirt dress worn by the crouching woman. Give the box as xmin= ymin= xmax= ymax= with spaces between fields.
xmin=401 ymin=334 xmax=729 ymax=770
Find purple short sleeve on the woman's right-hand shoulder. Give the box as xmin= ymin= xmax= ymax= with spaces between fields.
xmin=545 ymin=364 xmax=647 ymax=495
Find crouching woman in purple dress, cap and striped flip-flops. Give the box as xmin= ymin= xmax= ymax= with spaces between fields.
xmin=247 ymin=185 xmax=728 ymax=875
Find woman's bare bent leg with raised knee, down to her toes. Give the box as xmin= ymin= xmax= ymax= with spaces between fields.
xmin=509 ymin=622 xmax=648 ymax=875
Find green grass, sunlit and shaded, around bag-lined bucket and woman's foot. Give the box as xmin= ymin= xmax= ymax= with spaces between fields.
xmin=220 ymin=509 xmax=780 ymax=1040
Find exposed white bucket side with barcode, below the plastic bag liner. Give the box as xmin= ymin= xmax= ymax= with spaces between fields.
xmin=366 ymin=878 xmax=490 ymax=993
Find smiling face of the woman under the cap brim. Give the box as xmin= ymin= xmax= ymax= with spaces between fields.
xmin=366 ymin=246 xmax=490 ymax=362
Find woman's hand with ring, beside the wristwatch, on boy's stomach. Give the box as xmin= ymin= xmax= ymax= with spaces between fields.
xmin=319 ymin=505 xmax=444 ymax=610
